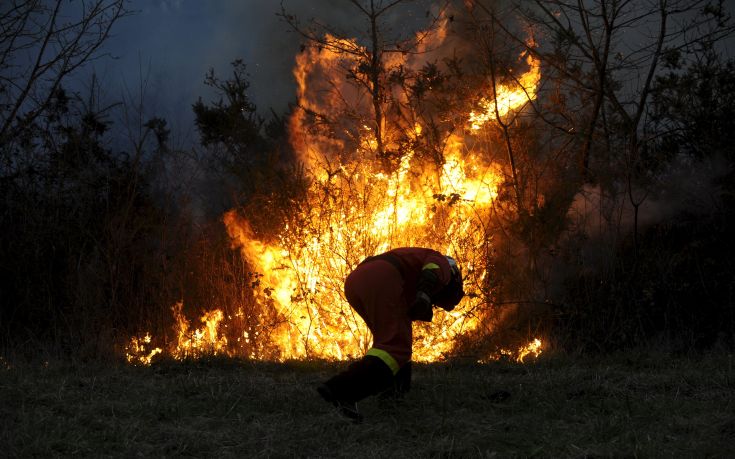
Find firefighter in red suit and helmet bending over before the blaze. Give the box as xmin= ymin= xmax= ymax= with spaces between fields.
xmin=317 ymin=247 xmax=464 ymax=422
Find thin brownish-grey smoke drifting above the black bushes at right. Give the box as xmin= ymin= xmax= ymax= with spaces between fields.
xmin=547 ymin=152 xmax=730 ymax=306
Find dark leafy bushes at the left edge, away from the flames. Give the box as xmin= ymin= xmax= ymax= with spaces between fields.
xmin=0 ymin=82 xmax=178 ymax=353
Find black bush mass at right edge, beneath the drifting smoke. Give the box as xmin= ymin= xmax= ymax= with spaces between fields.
xmin=552 ymin=210 xmax=735 ymax=353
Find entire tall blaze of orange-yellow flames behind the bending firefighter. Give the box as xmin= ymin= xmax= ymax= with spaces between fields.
xmin=126 ymin=2 xmax=552 ymax=361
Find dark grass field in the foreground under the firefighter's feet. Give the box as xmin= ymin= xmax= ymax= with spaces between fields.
xmin=0 ymin=353 xmax=735 ymax=457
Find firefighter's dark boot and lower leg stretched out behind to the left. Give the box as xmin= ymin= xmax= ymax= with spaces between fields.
xmin=317 ymin=355 xmax=393 ymax=422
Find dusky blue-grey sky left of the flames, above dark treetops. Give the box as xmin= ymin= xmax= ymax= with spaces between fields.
xmin=88 ymin=0 xmax=396 ymax=143
